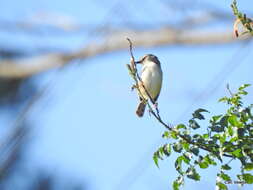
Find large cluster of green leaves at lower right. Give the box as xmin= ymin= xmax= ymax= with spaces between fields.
xmin=153 ymin=84 xmax=253 ymax=190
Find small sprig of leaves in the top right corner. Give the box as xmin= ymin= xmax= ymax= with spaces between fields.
xmin=231 ymin=0 xmax=253 ymax=36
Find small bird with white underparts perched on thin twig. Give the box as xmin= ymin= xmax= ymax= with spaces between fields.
xmin=136 ymin=54 xmax=163 ymax=117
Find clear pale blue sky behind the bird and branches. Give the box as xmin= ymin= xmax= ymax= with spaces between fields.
xmin=0 ymin=0 xmax=253 ymax=190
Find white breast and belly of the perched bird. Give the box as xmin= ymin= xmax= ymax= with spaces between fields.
xmin=141 ymin=61 xmax=162 ymax=99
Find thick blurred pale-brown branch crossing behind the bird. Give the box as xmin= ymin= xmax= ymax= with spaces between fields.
xmin=0 ymin=28 xmax=249 ymax=78
